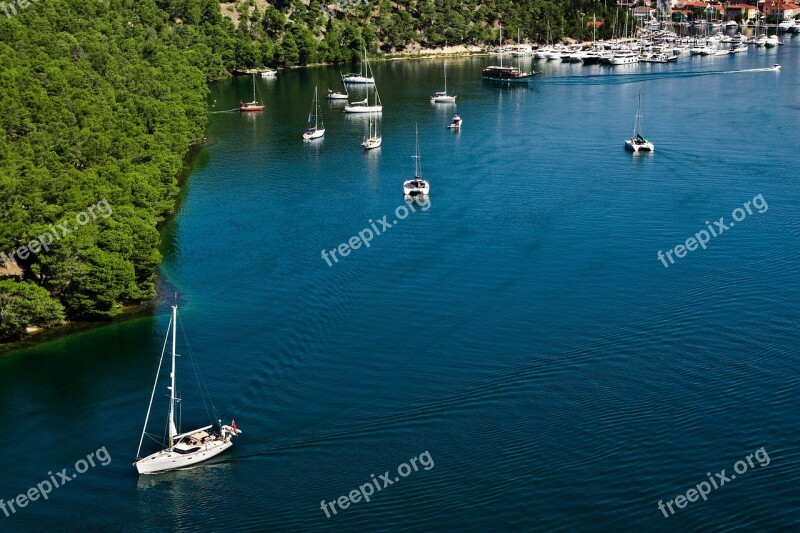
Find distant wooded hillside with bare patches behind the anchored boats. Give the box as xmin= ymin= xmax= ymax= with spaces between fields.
xmin=219 ymin=0 xmax=625 ymax=68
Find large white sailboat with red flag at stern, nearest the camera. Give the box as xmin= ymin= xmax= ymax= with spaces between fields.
xmin=133 ymin=305 xmax=241 ymax=474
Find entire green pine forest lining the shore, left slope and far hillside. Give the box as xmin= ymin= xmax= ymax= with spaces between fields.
xmin=0 ymin=0 xmax=624 ymax=341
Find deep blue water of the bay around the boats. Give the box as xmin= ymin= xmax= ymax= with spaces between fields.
xmin=0 ymin=36 xmax=800 ymax=531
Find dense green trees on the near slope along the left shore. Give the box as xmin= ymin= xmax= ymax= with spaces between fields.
xmin=0 ymin=0 xmax=236 ymax=338
